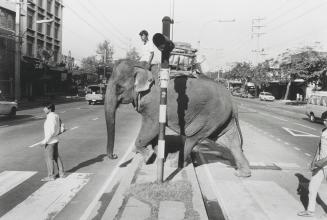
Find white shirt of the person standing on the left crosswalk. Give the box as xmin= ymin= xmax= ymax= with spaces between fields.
xmin=42 ymin=112 xmax=60 ymax=144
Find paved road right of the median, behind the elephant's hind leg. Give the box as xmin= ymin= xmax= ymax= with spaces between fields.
xmin=196 ymin=98 xmax=327 ymax=220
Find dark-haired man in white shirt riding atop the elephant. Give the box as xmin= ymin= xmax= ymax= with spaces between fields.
xmin=139 ymin=30 xmax=154 ymax=69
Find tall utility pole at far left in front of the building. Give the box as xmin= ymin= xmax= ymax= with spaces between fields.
xmin=15 ymin=0 xmax=22 ymax=101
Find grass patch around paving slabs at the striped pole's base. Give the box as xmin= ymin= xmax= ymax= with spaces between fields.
xmin=126 ymin=180 xmax=200 ymax=220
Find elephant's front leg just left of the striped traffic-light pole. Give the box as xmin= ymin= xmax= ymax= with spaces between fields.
xmin=135 ymin=116 xmax=159 ymax=155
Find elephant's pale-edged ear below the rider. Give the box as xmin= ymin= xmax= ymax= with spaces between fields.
xmin=134 ymin=67 xmax=153 ymax=92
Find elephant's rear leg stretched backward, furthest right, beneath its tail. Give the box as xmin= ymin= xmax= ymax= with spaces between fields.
xmin=217 ymin=119 xmax=251 ymax=177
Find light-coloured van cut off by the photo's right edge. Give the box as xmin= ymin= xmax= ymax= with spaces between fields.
xmin=306 ymin=91 xmax=327 ymax=122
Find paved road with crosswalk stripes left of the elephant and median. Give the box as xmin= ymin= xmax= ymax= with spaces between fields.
xmin=0 ymin=102 xmax=140 ymax=219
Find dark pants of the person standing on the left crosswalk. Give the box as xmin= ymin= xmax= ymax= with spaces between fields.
xmin=44 ymin=142 xmax=64 ymax=177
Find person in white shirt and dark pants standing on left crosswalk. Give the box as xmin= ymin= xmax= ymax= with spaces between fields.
xmin=41 ymin=103 xmax=65 ymax=181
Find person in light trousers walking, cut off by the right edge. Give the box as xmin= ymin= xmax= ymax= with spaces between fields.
xmin=298 ymin=117 xmax=327 ymax=217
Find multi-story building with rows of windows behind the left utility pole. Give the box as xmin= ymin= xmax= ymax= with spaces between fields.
xmin=0 ymin=0 xmax=65 ymax=98
